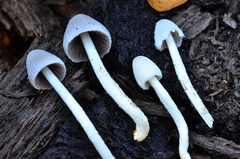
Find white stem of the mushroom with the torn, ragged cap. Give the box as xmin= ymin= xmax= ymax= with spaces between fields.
xmin=166 ymin=33 xmax=213 ymax=128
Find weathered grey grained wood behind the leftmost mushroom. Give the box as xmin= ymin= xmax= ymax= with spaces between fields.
xmin=0 ymin=35 xmax=87 ymax=158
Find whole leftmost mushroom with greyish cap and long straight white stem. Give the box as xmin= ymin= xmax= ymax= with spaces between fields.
xmin=26 ymin=50 xmax=114 ymax=159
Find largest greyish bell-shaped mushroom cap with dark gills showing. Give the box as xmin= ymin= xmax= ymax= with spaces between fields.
xmin=63 ymin=14 xmax=112 ymax=62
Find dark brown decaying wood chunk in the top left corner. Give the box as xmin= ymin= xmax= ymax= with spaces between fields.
xmin=0 ymin=0 xmax=59 ymax=37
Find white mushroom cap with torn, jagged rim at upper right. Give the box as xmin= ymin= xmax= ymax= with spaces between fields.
xmin=154 ymin=19 xmax=184 ymax=51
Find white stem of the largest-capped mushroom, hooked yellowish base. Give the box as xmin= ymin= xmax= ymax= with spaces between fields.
xmin=80 ymin=33 xmax=149 ymax=142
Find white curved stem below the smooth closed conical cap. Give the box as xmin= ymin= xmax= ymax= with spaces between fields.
xmin=148 ymin=77 xmax=191 ymax=159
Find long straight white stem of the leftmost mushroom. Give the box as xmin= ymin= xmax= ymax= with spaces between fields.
xmin=41 ymin=67 xmax=114 ymax=159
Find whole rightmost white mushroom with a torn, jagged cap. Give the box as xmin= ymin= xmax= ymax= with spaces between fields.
xmin=154 ymin=19 xmax=213 ymax=128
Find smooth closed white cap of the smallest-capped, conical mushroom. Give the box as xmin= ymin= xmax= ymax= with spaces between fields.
xmin=132 ymin=56 xmax=162 ymax=90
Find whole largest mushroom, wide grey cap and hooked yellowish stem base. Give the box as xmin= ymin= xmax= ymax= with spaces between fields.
xmin=63 ymin=14 xmax=149 ymax=142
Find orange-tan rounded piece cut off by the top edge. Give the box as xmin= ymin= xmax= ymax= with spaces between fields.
xmin=148 ymin=0 xmax=187 ymax=12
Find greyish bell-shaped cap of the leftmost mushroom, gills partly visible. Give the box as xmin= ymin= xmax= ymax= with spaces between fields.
xmin=26 ymin=50 xmax=66 ymax=89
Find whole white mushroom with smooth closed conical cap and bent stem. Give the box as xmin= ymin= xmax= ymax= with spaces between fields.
xmin=132 ymin=56 xmax=190 ymax=159
